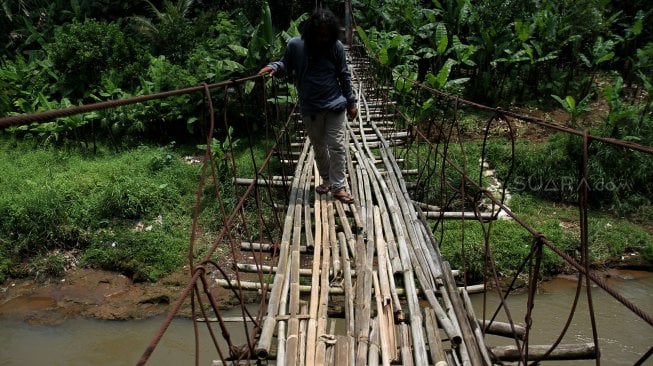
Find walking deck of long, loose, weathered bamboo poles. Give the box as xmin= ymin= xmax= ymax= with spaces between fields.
xmin=214 ymin=49 xmax=593 ymax=366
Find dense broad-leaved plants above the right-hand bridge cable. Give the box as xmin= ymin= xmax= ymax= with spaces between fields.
xmin=355 ymin=0 xmax=653 ymax=104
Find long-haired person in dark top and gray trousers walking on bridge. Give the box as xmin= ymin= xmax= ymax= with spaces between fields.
xmin=258 ymin=9 xmax=358 ymax=203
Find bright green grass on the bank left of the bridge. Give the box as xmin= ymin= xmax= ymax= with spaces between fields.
xmin=0 ymin=140 xmax=200 ymax=280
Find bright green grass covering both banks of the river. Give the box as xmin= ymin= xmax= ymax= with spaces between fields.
xmin=0 ymin=131 xmax=653 ymax=280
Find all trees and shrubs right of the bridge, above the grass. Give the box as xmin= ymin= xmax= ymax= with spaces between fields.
xmin=354 ymin=0 xmax=653 ymax=214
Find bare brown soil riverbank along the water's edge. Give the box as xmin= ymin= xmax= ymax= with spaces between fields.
xmin=0 ymin=266 xmax=651 ymax=325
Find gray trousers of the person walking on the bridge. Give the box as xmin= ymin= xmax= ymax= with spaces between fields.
xmin=303 ymin=109 xmax=347 ymax=189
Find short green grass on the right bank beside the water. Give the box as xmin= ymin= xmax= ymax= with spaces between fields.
xmin=435 ymin=194 xmax=653 ymax=280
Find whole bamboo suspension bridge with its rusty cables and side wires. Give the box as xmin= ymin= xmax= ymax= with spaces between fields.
xmin=0 ymin=40 xmax=653 ymax=366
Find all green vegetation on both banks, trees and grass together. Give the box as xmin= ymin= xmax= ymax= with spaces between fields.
xmin=0 ymin=0 xmax=653 ymax=280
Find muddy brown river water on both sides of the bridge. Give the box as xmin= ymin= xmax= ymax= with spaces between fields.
xmin=0 ymin=271 xmax=653 ymax=366
